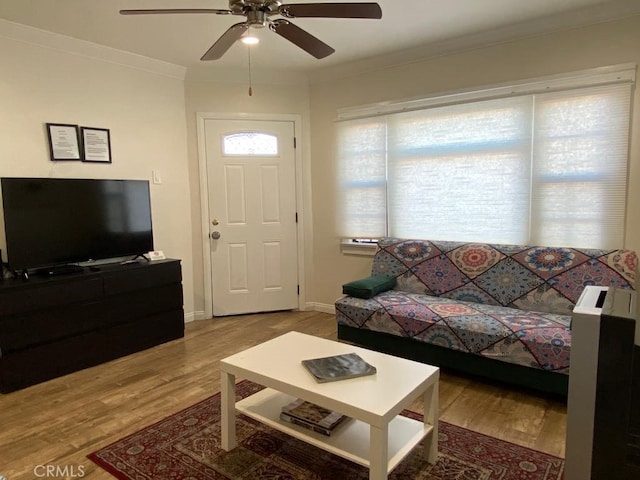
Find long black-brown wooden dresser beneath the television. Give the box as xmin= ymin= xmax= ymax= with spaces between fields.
xmin=0 ymin=260 xmax=184 ymax=393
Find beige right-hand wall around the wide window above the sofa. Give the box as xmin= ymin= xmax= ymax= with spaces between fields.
xmin=310 ymin=16 xmax=640 ymax=305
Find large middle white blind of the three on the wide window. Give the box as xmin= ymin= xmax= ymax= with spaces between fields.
xmin=388 ymin=98 xmax=532 ymax=243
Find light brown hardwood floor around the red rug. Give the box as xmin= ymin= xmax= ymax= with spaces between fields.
xmin=0 ymin=312 xmax=566 ymax=480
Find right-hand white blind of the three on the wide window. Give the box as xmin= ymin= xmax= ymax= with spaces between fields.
xmin=531 ymin=85 xmax=631 ymax=248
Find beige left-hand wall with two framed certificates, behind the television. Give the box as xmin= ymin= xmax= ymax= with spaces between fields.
xmin=0 ymin=30 xmax=194 ymax=317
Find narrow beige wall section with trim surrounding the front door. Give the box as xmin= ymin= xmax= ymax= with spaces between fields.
xmin=185 ymin=80 xmax=312 ymax=316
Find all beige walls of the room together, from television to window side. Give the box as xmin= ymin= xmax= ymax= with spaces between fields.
xmin=0 ymin=17 xmax=640 ymax=318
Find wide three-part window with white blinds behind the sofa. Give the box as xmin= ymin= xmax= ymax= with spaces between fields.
xmin=337 ymin=68 xmax=631 ymax=248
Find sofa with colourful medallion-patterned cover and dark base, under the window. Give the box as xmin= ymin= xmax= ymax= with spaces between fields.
xmin=335 ymin=238 xmax=638 ymax=395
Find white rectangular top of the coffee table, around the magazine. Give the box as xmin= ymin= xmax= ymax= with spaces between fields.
xmin=220 ymin=332 xmax=438 ymax=423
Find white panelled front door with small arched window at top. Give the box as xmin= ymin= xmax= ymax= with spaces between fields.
xmin=205 ymin=119 xmax=298 ymax=316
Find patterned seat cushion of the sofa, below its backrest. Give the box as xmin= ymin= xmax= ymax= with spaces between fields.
xmin=336 ymin=290 xmax=571 ymax=374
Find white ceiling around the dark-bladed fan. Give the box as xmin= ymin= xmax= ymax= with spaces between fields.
xmin=0 ymin=0 xmax=640 ymax=76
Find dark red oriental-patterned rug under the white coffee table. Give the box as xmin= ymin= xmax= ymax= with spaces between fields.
xmin=88 ymin=381 xmax=564 ymax=480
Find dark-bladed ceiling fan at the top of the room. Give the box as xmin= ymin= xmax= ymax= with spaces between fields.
xmin=120 ymin=0 xmax=382 ymax=60
